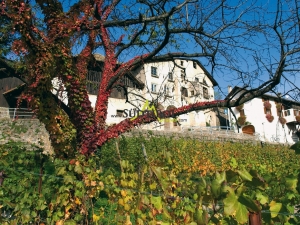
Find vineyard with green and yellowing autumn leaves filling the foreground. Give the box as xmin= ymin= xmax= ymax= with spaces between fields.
xmin=0 ymin=133 xmax=300 ymax=225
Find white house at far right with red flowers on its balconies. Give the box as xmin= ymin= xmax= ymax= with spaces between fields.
xmin=226 ymin=87 xmax=300 ymax=144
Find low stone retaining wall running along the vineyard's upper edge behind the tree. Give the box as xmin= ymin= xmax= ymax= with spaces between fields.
xmin=0 ymin=117 xmax=268 ymax=154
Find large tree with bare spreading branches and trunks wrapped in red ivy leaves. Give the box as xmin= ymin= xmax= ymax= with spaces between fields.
xmin=0 ymin=0 xmax=299 ymax=157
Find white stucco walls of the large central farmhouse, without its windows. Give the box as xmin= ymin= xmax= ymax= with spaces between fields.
xmin=53 ymin=59 xmax=216 ymax=130
